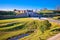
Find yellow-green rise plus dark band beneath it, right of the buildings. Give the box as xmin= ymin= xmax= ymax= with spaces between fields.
xmin=38 ymin=10 xmax=60 ymax=17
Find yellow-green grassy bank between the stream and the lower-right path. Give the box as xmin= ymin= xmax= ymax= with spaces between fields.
xmin=20 ymin=21 xmax=60 ymax=40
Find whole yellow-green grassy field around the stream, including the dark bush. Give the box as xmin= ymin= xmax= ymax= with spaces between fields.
xmin=0 ymin=18 xmax=60 ymax=40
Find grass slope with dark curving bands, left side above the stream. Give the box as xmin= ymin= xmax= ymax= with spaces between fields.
xmin=0 ymin=18 xmax=32 ymax=40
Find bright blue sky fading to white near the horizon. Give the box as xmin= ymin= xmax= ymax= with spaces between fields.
xmin=0 ymin=0 xmax=60 ymax=10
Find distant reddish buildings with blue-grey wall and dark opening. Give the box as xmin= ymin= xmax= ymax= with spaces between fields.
xmin=14 ymin=9 xmax=38 ymax=17
